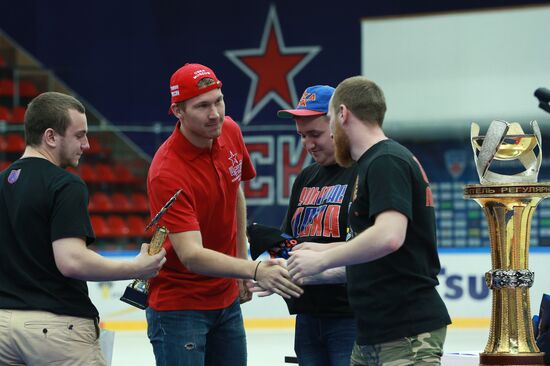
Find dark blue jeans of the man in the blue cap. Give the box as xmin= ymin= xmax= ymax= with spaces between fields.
xmin=294 ymin=314 xmax=357 ymax=366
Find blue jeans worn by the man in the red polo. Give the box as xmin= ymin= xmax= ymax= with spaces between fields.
xmin=145 ymin=299 xmax=247 ymax=366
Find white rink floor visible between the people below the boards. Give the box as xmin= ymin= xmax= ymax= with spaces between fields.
xmin=112 ymin=328 xmax=488 ymax=366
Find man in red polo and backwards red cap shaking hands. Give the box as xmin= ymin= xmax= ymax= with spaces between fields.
xmin=146 ymin=64 xmax=302 ymax=366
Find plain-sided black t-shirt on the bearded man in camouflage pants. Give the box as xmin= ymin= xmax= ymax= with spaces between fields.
xmin=347 ymin=140 xmax=451 ymax=345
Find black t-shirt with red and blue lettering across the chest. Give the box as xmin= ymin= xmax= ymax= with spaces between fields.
xmin=281 ymin=163 xmax=355 ymax=317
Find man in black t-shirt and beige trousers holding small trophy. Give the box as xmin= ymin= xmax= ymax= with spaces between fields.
xmin=0 ymin=92 xmax=166 ymax=365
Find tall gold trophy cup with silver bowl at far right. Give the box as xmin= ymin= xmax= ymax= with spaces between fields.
xmin=464 ymin=121 xmax=550 ymax=366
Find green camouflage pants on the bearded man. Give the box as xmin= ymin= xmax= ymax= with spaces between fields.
xmin=350 ymin=327 xmax=447 ymax=366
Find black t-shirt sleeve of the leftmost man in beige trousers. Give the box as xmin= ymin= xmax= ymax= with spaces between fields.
xmin=50 ymin=180 xmax=95 ymax=245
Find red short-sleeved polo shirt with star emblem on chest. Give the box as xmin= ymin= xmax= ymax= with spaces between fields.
xmin=147 ymin=117 xmax=256 ymax=310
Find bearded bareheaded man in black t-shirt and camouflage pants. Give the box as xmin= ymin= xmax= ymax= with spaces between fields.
xmin=288 ymin=76 xmax=450 ymax=366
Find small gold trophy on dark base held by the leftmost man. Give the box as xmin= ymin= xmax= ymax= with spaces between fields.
xmin=120 ymin=189 xmax=181 ymax=310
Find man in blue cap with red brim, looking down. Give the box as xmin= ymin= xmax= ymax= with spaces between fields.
xmin=277 ymin=85 xmax=356 ymax=366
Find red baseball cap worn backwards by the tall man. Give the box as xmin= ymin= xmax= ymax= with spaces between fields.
xmin=170 ymin=64 xmax=222 ymax=103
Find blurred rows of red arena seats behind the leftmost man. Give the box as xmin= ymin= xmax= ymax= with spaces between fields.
xmin=0 ymin=53 xmax=152 ymax=249
